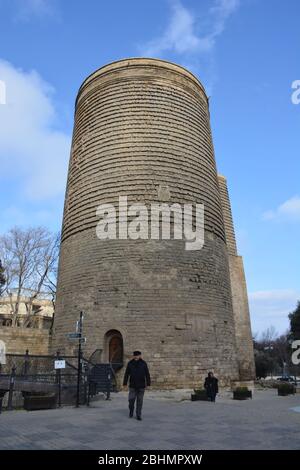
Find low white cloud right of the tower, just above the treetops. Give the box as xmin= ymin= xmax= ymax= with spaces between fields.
xmin=249 ymin=289 xmax=300 ymax=333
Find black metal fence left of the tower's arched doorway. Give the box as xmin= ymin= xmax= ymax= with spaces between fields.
xmin=0 ymin=350 xmax=115 ymax=412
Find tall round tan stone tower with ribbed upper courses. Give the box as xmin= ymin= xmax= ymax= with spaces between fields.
xmin=53 ymin=59 xmax=253 ymax=388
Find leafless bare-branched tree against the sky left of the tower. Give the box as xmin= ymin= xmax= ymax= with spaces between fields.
xmin=0 ymin=227 xmax=59 ymax=326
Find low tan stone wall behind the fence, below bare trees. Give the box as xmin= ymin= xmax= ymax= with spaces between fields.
xmin=0 ymin=326 xmax=49 ymax=354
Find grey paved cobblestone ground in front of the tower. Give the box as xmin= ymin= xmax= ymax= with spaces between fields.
xmin=0 ymin=390 xmax=300 ymax=450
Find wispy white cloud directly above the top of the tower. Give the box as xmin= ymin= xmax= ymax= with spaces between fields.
xmin=140 ymin=0 xmax=239 ymax=57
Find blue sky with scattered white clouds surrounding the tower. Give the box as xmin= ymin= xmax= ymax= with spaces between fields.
xmin=0 ymin=0 xmax=300 ymax=334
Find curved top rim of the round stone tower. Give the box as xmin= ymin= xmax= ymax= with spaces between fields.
xmin=76 ymin=57 xmax=208 ymax=103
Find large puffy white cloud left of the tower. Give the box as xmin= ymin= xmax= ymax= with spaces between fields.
xmin=0 ymin=60 xmax=70 ymax=200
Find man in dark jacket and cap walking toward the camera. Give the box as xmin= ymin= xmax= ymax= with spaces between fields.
xmin=123 ymin=351 xmax=151 ymax=421
